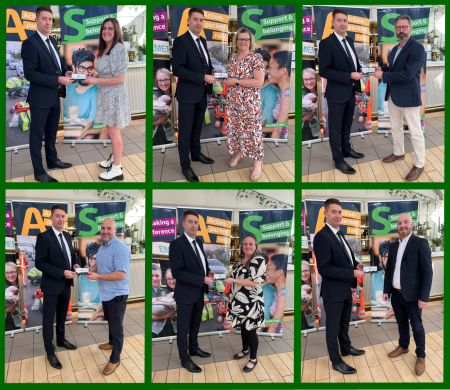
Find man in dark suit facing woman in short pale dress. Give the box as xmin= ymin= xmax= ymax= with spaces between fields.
xmin=21 ymin=6 xmax=73 ymax=182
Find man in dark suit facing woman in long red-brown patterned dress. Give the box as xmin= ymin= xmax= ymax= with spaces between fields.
xmin=172 ymin=7 xmax=217 ymax=182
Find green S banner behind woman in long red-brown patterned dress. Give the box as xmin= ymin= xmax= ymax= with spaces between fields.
xmin=237 ymin=5 xmax=295 ymax=141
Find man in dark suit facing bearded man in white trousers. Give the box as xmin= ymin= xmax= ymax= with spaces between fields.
xmin=319 ymin=9 xmax=364 ymax=174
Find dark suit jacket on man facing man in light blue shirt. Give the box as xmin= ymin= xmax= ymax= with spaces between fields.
xmin=36 ymin=228 xmax=78 ymax=295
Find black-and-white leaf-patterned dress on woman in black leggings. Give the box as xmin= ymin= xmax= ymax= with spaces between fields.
xmin=227 ymin=256 xmax=267 ymax=330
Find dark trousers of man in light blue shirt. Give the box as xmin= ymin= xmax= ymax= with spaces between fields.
xmin=102 ymin=295 xmax=128 ymax=364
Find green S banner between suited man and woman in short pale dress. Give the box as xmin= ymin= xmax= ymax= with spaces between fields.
xmin=59 ymin=5 xmax=117 ymax=144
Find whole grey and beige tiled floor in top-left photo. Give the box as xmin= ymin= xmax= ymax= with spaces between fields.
xmin=6 ymin=119 xmax=146 ymax=182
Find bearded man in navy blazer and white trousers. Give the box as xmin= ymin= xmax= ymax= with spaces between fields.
xmin=374 ymin=15 xmax=427 ymax=181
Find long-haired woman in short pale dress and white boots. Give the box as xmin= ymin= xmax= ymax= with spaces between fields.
xmin=86 ymin=18 xmax=131 ymax=181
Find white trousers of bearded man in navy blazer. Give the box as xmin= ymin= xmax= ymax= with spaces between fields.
xmin=388 ymin=96 xmax=425 ymax=168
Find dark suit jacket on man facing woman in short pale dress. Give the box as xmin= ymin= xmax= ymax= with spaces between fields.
xmin=21 ymin=32 xmax=68 ymax=108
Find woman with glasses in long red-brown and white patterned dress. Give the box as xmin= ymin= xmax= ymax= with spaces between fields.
xmin=223 ymin=27 xmax=265 ymax=181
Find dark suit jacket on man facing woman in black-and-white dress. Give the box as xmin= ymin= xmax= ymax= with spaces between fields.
xmin=169 ymin=234 xmax=211 ymax=304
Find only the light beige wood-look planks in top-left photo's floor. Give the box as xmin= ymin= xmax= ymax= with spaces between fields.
xmin=6 ymin=152 xmax=145 ymax=183
